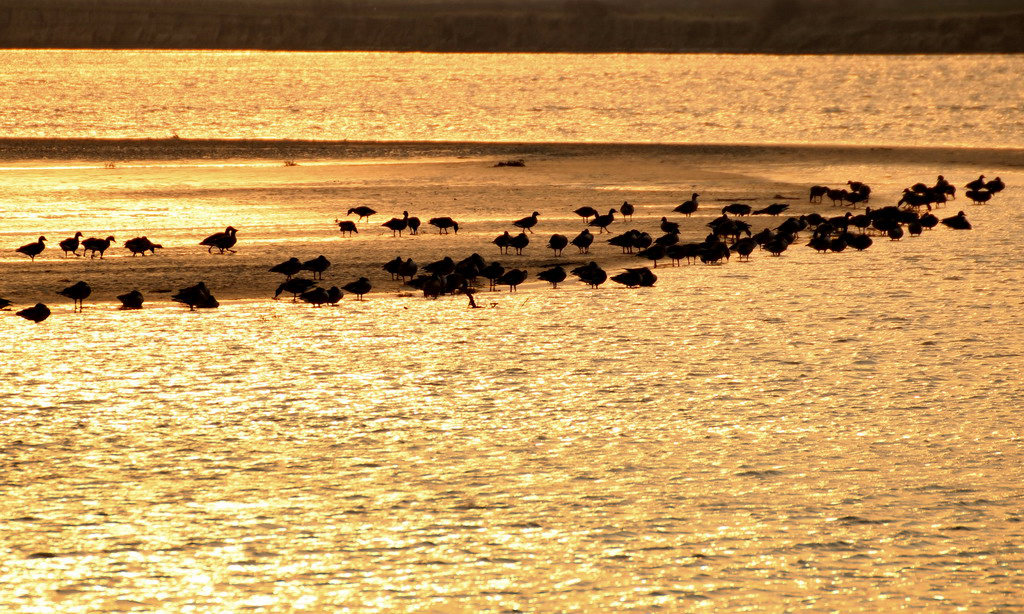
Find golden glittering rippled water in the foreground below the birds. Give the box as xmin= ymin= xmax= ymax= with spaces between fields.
xmin=0 ymin=196 xmax=1024 ymax=612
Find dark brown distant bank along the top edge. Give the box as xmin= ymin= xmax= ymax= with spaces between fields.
xmin=0 ymin=0 xmax=1024 ymax=53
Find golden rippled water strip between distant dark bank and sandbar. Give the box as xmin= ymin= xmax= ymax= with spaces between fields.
xmin=0 ymin=50 xmax=1024 ymax=147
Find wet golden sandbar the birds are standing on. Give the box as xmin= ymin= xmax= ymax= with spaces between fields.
xmin=0 ymin=139 xmax=1024 ymax=308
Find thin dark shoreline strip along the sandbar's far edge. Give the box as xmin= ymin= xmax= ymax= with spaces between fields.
xmin=0 ymin=138 xmax=1024 ymax=167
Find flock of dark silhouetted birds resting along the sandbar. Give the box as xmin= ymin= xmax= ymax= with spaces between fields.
xmin=0 ymin=175 xmax=1006 ymax=322
